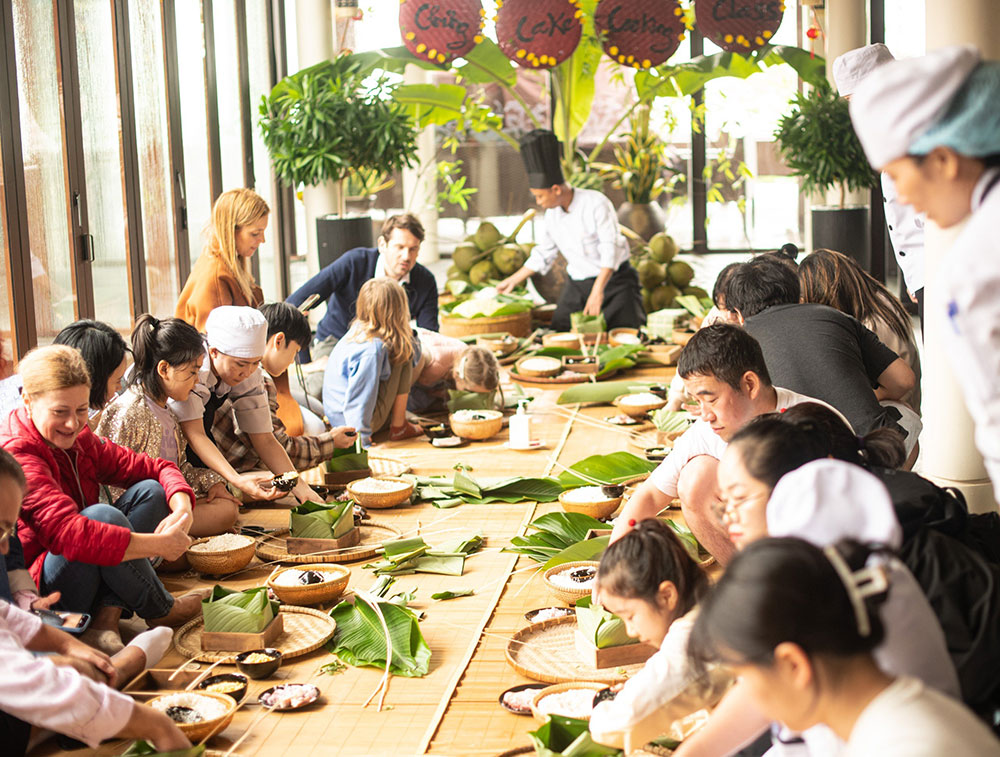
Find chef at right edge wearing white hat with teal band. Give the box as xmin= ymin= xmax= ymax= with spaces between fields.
xmin=851 ymin=45 xmax=1000 ymax=504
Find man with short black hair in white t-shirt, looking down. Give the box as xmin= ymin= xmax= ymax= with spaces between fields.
xmin=611 ymin=323 xmax=850 ymax=565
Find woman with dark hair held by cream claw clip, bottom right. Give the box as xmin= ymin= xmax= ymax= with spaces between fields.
xmin=688 ymin=538 xmax=1000 ymax=757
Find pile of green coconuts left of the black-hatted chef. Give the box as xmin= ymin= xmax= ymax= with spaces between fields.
xmin=445 ymin=211 xmax=534 ymax=295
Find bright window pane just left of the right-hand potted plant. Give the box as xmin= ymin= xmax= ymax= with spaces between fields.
xmin=705 ymin=3 xmax=802 ymax=249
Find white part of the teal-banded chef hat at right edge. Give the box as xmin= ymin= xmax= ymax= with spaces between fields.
xmin=851 ymin=45 xmax=980 ymax=169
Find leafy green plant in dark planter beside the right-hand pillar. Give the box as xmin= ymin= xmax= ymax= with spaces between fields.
xmin=774 ymin=82 xmax=877 ymax=271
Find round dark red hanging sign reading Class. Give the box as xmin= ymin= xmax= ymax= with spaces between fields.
xmin=694 ymin=0 xmax=785 ymax=54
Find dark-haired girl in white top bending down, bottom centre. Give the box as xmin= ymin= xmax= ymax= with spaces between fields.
xmin=590 ymin=518 xmax=732 ymax=747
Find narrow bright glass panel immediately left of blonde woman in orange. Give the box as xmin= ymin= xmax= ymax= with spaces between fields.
xmin=174 ymin=0 xmax=212 ymax=265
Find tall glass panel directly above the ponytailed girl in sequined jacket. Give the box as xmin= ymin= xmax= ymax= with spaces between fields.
xmin=129 ymin=0 xmax=180 ymax=317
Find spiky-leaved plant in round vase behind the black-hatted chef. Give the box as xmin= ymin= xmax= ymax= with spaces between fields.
xmin=592 ymin=104 xmax=668 ymax=242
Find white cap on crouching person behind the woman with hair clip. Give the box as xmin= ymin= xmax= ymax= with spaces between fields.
xmin=767 ymin=459 xmax=903 ymax=548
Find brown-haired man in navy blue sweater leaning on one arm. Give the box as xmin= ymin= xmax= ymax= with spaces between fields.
xmin=288 ymin=213 xmax=438 ymax=352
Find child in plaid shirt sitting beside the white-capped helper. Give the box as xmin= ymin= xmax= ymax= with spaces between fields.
xmin=212 ymin=302 xmax=355 ymax=473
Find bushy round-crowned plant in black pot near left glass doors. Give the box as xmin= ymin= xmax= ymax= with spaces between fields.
xmin=259 ymin=55 xmax=417 ymax=267
